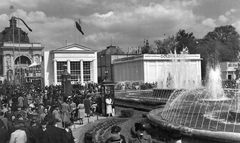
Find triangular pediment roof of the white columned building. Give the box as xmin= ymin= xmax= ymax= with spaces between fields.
xmin=52 ymin=44 xmax=96 ymax=53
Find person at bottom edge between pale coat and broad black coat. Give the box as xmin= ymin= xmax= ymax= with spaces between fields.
xmin=36 ymin=121 xmax=47 ymax=143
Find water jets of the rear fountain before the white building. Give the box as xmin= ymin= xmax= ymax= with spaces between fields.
xmin=157 ymin=52 xmax=201 ymax=89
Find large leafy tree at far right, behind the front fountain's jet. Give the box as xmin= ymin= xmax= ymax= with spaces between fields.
xmin=196 ymin=25 xmax=240 ymax=79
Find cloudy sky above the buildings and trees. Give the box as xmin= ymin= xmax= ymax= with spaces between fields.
xmin=0 ymin=0 xmax=240 ymax=51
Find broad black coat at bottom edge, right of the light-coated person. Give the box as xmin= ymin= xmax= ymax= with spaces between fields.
xmin=44 ymin=126 xmax=68 ymax=143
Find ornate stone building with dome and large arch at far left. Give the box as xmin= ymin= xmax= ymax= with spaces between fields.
xmin=0 ymin=17 xmax=44 ymax=83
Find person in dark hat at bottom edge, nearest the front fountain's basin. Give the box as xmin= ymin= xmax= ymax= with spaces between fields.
xmin=128 ymin=123 xmax=152 ymax=143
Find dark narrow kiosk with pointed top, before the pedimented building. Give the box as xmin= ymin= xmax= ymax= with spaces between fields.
xmin=61 ymin=65 xmax=72 ymax=97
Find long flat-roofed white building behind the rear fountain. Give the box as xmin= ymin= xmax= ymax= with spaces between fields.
xmin=113 ymin=54 xmax=202 ymax=88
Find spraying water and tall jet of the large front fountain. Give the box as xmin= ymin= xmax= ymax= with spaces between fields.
xmin=160 ymin=61 xmax=240 ymax=133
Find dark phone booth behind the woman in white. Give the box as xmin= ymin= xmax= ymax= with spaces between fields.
xmin=101 ymin=81 xmax=116 ymax=116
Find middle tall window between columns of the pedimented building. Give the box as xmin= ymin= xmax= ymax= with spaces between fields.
xmin=70 ymin=62 xmax=81 ymax=82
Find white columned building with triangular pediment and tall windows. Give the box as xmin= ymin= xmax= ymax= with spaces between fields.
xmin=43 ymin=44 xmax=97 ymax=85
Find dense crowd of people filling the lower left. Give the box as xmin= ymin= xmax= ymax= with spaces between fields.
xmin=0 ymin=82 xmax=98 ymax=143
